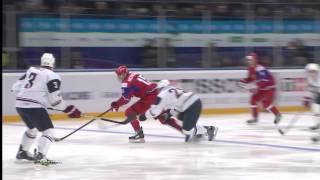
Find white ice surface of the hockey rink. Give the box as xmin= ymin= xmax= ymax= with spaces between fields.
xmin=2 ymin=113 xmax=320 ymax=180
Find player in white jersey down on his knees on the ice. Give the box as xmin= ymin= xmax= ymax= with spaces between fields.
xmin=146 ymin=80 xmax=218 ymax=142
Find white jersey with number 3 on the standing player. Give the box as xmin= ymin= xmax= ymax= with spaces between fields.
xmin=11 ymin=67 xmax=66 ymax=110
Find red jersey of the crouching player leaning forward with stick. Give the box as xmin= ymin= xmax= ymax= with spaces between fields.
xmin=118 ymin=73 xmax=158 ymax=105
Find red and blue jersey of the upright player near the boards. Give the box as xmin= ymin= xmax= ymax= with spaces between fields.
xmin=244 ymin=64 xmax=275 ymax=90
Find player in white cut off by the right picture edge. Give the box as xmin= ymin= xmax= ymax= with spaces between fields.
xmin=304 ymin=63 xmax=320 ymax=141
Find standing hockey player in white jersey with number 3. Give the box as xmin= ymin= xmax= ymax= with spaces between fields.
xmin=11 ymin=53 xmax=81 ymax=165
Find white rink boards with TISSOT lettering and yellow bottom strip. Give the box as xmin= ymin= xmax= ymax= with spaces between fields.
xmin=2 ymin=69 xmax=306 ymax=121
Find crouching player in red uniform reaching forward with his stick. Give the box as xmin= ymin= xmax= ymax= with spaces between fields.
xmin=111 ymin=66 xmax=158 ymax=143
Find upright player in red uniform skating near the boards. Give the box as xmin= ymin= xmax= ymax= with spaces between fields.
xmin=240 ymin=53 xmax=281 ymax=124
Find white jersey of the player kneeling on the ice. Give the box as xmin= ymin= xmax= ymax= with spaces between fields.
xmin=148 ymin=86 xmax=199 ymax=118
